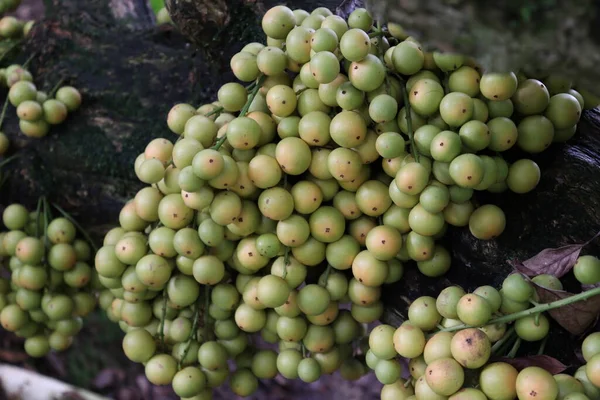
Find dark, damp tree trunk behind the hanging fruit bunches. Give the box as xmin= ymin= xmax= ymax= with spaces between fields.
xmin=0 ymin=0 xmax=600 ymax=372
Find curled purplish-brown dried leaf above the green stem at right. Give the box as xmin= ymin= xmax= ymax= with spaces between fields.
xmin=511 ymin=232 xmax=600 ymax=278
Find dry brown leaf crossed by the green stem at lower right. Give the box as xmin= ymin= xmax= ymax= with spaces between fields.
xmin=533 ymin=283 xmax=600 ymax=335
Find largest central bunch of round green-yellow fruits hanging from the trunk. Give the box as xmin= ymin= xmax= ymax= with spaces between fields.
xmin=95 ymin=6 xmax=600 ymax=400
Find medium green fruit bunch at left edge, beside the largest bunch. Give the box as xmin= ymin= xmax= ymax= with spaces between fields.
xmin=0 ymin=204 xmax=101 ymax=357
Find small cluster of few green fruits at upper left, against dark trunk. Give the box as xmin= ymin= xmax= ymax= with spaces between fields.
xmin=0 ymin=64 xmax=81 ymax=140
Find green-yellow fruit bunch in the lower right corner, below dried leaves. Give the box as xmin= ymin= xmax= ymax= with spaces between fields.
xmin=366 ymin=266 xmax=600 ymax=400
